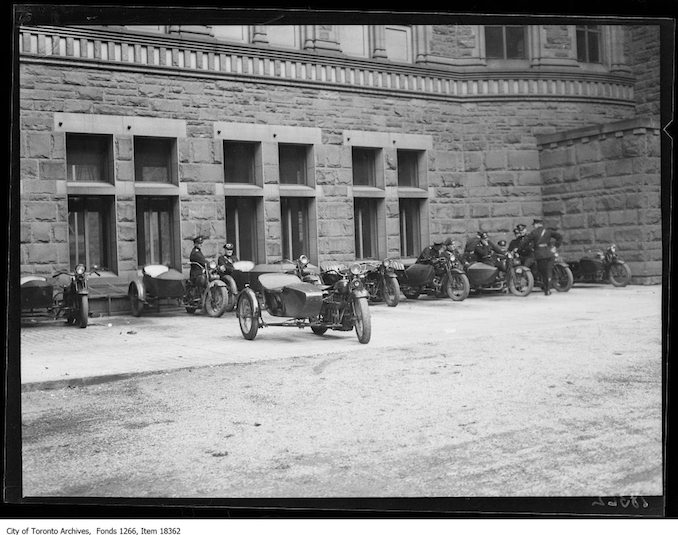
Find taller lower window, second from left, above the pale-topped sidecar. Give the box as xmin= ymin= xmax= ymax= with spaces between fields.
xmin=137 ymin=196 xmax=177 ymax=267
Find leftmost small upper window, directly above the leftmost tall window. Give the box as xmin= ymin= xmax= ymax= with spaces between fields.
xmin=66 ymin=134 xmax=113 ymax=182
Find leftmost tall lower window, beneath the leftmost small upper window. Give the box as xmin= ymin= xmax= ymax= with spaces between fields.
xmin=68 ymin=196 xmax=114 ymax=270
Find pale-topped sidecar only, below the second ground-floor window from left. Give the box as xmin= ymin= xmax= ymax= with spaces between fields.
xmin=127 ymin=264 xmax=186 ymax=317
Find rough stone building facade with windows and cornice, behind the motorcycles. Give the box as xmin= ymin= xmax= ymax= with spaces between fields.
xmin=19 ymin=25 xmax=661 ymax=310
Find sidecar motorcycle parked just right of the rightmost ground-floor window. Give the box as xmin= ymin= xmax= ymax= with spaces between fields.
xmin=396 ymin=250 xmax=470 ymax=301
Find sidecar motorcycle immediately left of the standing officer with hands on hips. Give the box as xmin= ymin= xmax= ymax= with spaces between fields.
xmin=463 ymin=251 xmax=534 ymax=297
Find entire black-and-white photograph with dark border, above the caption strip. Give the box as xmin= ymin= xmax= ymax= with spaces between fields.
xmin=9 ymin=4 xmax=675 ymax=517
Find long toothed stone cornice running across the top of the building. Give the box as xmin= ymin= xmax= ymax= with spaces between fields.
xmin=20 ymin=26 xmax=633 ymax=105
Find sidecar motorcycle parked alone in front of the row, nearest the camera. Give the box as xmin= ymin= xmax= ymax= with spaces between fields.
xmin=236 ymin=255 xmax=372 ymax=344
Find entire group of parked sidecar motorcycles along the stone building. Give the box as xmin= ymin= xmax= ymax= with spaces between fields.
xmin=21 ymin=241 xmax=631 ymax=344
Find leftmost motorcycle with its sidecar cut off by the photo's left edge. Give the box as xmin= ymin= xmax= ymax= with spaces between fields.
xmin=20 ymin=264 xmax=101 ymax=329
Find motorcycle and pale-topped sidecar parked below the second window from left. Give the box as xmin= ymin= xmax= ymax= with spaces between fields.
xmin=127 ymin=260 xmax=228 ymax=318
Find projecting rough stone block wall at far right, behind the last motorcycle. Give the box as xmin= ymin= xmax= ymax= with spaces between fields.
xmin=538 ymin=118 xmax=662 ymax=284
